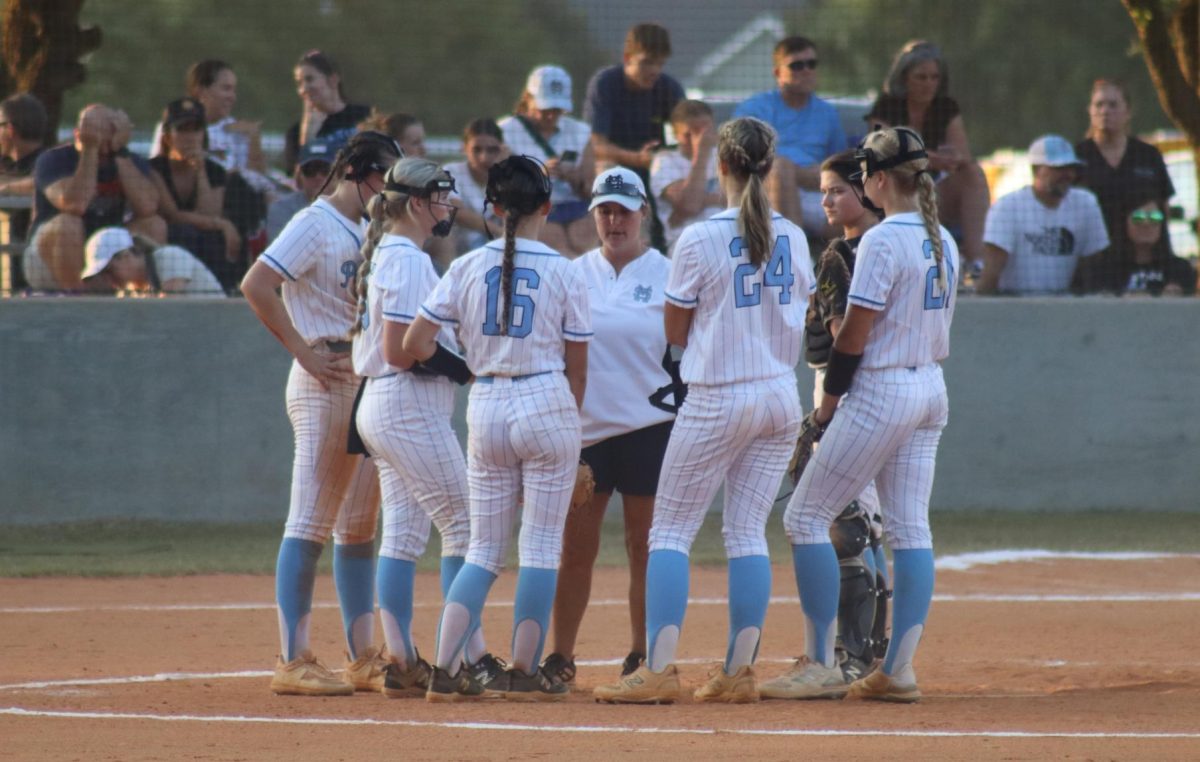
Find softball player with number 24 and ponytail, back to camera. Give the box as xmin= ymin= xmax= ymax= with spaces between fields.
xmin=595 ymin=118 xmax=814 ymax=703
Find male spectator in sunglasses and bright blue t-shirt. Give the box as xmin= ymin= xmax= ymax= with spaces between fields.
xmin=733 ymin=37 xmax=847 ymax=239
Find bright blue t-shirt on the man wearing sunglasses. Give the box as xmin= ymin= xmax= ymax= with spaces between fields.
xmin=733 ymin=89 xmax=847 ymax=167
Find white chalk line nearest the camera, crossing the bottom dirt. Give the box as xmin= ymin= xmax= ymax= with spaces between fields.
xmin=0 ymin=707 xmax=1200 ymax=740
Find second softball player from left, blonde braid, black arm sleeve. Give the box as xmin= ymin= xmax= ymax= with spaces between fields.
xmin=353 ymin=157 xmax=499 ymax=698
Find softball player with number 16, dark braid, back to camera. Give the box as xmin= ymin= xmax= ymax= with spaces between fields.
xmin=403 ymin=156 xmax=592 ymax=702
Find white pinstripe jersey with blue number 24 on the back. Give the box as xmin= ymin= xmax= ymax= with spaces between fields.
xmin=666 ymin=209 xmax=815 ymax=385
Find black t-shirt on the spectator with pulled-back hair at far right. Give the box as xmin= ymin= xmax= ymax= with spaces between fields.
xmin=1075 ymin=138 xmax=1175 ymax=240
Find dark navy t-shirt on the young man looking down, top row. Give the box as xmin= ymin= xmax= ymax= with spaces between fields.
xmin=583 ymin=66 xmax=684 ymax=151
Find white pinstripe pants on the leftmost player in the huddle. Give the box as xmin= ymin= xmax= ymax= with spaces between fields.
xmin=283 ymin=361 xmax=379 ymax=545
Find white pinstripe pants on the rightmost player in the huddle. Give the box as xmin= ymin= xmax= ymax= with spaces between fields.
xmin=784 ymin=364 xmax=949 ymax=550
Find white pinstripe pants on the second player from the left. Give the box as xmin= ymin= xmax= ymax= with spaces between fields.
xmin=358 ymin=372 xmax=470 ymax=560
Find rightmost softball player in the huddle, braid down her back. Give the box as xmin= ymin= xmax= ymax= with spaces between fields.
xmin=773 ymin=127 xmax=959 ymax=702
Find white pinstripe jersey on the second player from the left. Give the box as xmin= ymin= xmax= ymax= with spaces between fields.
xmin=354 ymin=233 xmax=458 ymax=378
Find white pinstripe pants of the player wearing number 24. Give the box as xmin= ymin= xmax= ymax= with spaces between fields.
xmin=650 ymin=373 xmax=803 ymax=558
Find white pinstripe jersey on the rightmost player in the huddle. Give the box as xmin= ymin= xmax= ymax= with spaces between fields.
xmin=850 ymin=212 xmax=959 ymax=368
